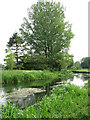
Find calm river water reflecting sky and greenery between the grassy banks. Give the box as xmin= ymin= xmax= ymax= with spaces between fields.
xmin=0 ymin=73 xmax=90 ymax=108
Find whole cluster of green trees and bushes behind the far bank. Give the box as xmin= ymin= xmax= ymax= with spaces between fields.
xmin=4 ymin=1 xmax=74 ymax=70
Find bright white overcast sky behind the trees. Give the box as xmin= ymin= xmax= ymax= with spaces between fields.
xmin=0 ymin=0 xmax=89 ymax=64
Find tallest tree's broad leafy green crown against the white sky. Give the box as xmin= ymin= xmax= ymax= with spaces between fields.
xmin=20 ymin=1 xmax=74 ymax=61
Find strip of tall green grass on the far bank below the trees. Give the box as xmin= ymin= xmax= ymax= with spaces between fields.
xmin=2 ymin=70 xmax=73 ymax=84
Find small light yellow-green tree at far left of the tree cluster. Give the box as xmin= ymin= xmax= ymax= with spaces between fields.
xmin=4 ymin=49 xmax=15 ymax=70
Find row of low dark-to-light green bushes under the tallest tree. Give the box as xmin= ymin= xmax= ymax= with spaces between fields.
xmin=19 ymin=53 xmax=72 ymax=71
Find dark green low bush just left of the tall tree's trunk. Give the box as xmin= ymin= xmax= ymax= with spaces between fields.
xmin=23 ymin=55 xmax=48 ymax=70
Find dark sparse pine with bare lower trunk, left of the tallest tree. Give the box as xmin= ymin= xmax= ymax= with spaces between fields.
xmin=7 ymin=33 xmax=24 ymax=66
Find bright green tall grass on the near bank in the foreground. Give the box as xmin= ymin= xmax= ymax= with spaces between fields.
xmin=1 ymin=84 xmax=88 ymax=118
